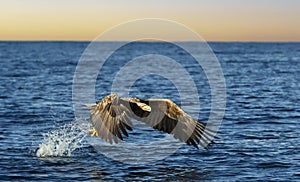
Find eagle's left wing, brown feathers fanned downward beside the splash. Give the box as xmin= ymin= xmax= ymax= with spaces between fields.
xmin=90 ymin=94 xmax=132 ymax=143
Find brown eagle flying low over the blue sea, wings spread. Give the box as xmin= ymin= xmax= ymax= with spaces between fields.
xmin=86 ymin=93 xmax=217 ymax=149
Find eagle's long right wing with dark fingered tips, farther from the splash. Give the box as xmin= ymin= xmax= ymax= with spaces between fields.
xmin=134 ymin=99 xmax=216 ymax=148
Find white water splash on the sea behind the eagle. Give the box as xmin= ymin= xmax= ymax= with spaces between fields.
xmin=36 ymin=119 xmax=91 ymax=157
